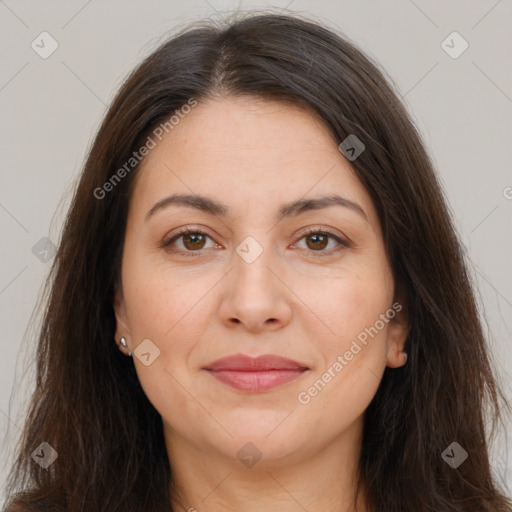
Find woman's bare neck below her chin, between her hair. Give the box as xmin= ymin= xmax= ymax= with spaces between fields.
xmin=164 ymin=420 xmax=367 ymax=512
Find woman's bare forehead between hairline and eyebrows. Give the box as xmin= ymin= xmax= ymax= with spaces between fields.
xmin=128 ymin=97 xmax=376 ymax=230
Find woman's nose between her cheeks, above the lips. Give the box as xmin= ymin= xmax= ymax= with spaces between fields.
xmin=219 ymin=239 xmax=293 ymax=333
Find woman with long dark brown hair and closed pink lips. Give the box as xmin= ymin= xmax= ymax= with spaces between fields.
xmin=3 ymin=9 xmax=512 ymax=512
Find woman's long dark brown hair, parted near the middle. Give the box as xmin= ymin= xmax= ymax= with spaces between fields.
xmin=4 ymin=9 xmax=511 ymax=512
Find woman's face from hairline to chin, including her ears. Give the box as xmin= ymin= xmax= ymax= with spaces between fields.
xmin=112 ymin=97 xmax=407 ymax=464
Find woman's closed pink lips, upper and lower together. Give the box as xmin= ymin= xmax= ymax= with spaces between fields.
xmin=204 ymin=354 xmax=309 ymax=392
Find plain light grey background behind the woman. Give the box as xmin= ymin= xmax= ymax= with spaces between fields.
xmin=0 ymin=0 xmax=512 ymax=499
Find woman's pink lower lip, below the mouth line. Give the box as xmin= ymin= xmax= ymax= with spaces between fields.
xmin=208 ymin=370 xmax=307 ymax=393
